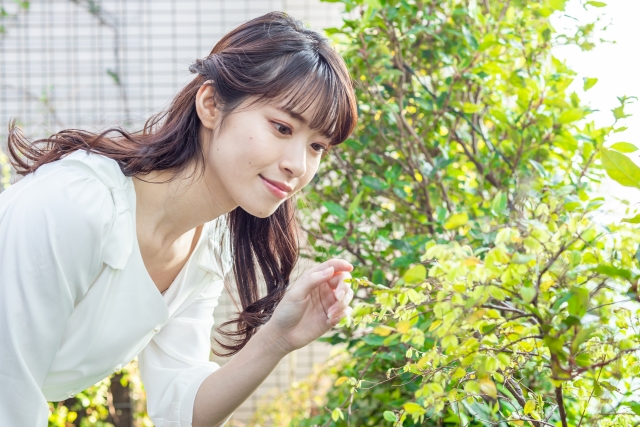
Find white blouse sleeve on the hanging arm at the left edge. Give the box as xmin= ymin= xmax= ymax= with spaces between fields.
xmin=0 ymin=164 xmax=114 ymax=426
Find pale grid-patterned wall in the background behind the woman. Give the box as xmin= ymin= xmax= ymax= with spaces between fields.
xmin=0 ymin=0 xmax=341 ymax=425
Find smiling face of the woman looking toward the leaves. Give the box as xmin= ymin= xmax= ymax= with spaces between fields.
xmin=198 ymin=88 xmax=330 ymax=218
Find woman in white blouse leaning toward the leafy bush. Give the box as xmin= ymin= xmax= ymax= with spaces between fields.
xmin=0 ymin=13 xmax=356 ymax=427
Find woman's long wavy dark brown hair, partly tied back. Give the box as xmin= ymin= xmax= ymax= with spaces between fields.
xmin=8 ymin=12 xmax=357 ymax=356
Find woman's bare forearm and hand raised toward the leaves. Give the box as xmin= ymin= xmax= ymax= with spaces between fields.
xmin=192 ymin=259 xmax=353 ymax=427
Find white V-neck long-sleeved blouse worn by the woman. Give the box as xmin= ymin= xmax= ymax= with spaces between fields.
xmin=0 ymin=151 xmax=231 ymax=427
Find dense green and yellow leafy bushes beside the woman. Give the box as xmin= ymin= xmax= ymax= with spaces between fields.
xmin=292 ymin=0 xmax=640 ymax=427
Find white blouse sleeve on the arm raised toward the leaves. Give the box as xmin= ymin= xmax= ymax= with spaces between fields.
xmin=138 ymin=280 xmax=231 ymax=427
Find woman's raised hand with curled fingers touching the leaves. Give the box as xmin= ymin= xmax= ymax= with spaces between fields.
xmin=262 ymin=258 xmax=353 ymax=357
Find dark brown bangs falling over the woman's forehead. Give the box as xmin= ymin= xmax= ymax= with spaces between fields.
xmin=255 ymin=52 xmax=357 ymax=145
